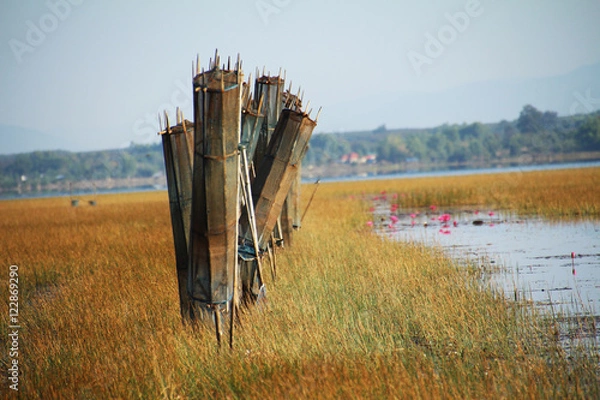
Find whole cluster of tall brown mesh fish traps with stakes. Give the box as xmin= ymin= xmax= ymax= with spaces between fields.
xmin=159 ymin=53 xmax=318 ymax=345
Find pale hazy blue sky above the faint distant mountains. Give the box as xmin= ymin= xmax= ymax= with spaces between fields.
xmin=0 ymin=0 xmax=600 ymax=149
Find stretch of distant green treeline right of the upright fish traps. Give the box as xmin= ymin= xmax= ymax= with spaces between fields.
xmin=305 ymin=105 xmax=600 ymax=165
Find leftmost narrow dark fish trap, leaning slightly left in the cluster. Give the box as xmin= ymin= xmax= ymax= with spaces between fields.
xmin=160 ymin=114 xmax=194 ymax=322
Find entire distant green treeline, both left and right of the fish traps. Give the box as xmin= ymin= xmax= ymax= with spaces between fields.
xmin=0 ymin=105 xmax=600 ymax=189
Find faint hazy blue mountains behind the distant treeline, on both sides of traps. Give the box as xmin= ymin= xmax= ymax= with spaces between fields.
xmin=0 ymin=63 xmax=600 ymax=154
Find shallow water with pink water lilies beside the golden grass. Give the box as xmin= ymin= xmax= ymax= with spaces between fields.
xmin=373 ymin=200 xmax=600 ymax=343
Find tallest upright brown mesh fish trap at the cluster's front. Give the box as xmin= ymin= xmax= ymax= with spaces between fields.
xmin=188 ymin=56 xmax=242 ymax=304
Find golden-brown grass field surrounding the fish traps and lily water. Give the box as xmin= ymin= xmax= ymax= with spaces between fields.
xmin=0 ymin=168 xmax=600 ymax=400
